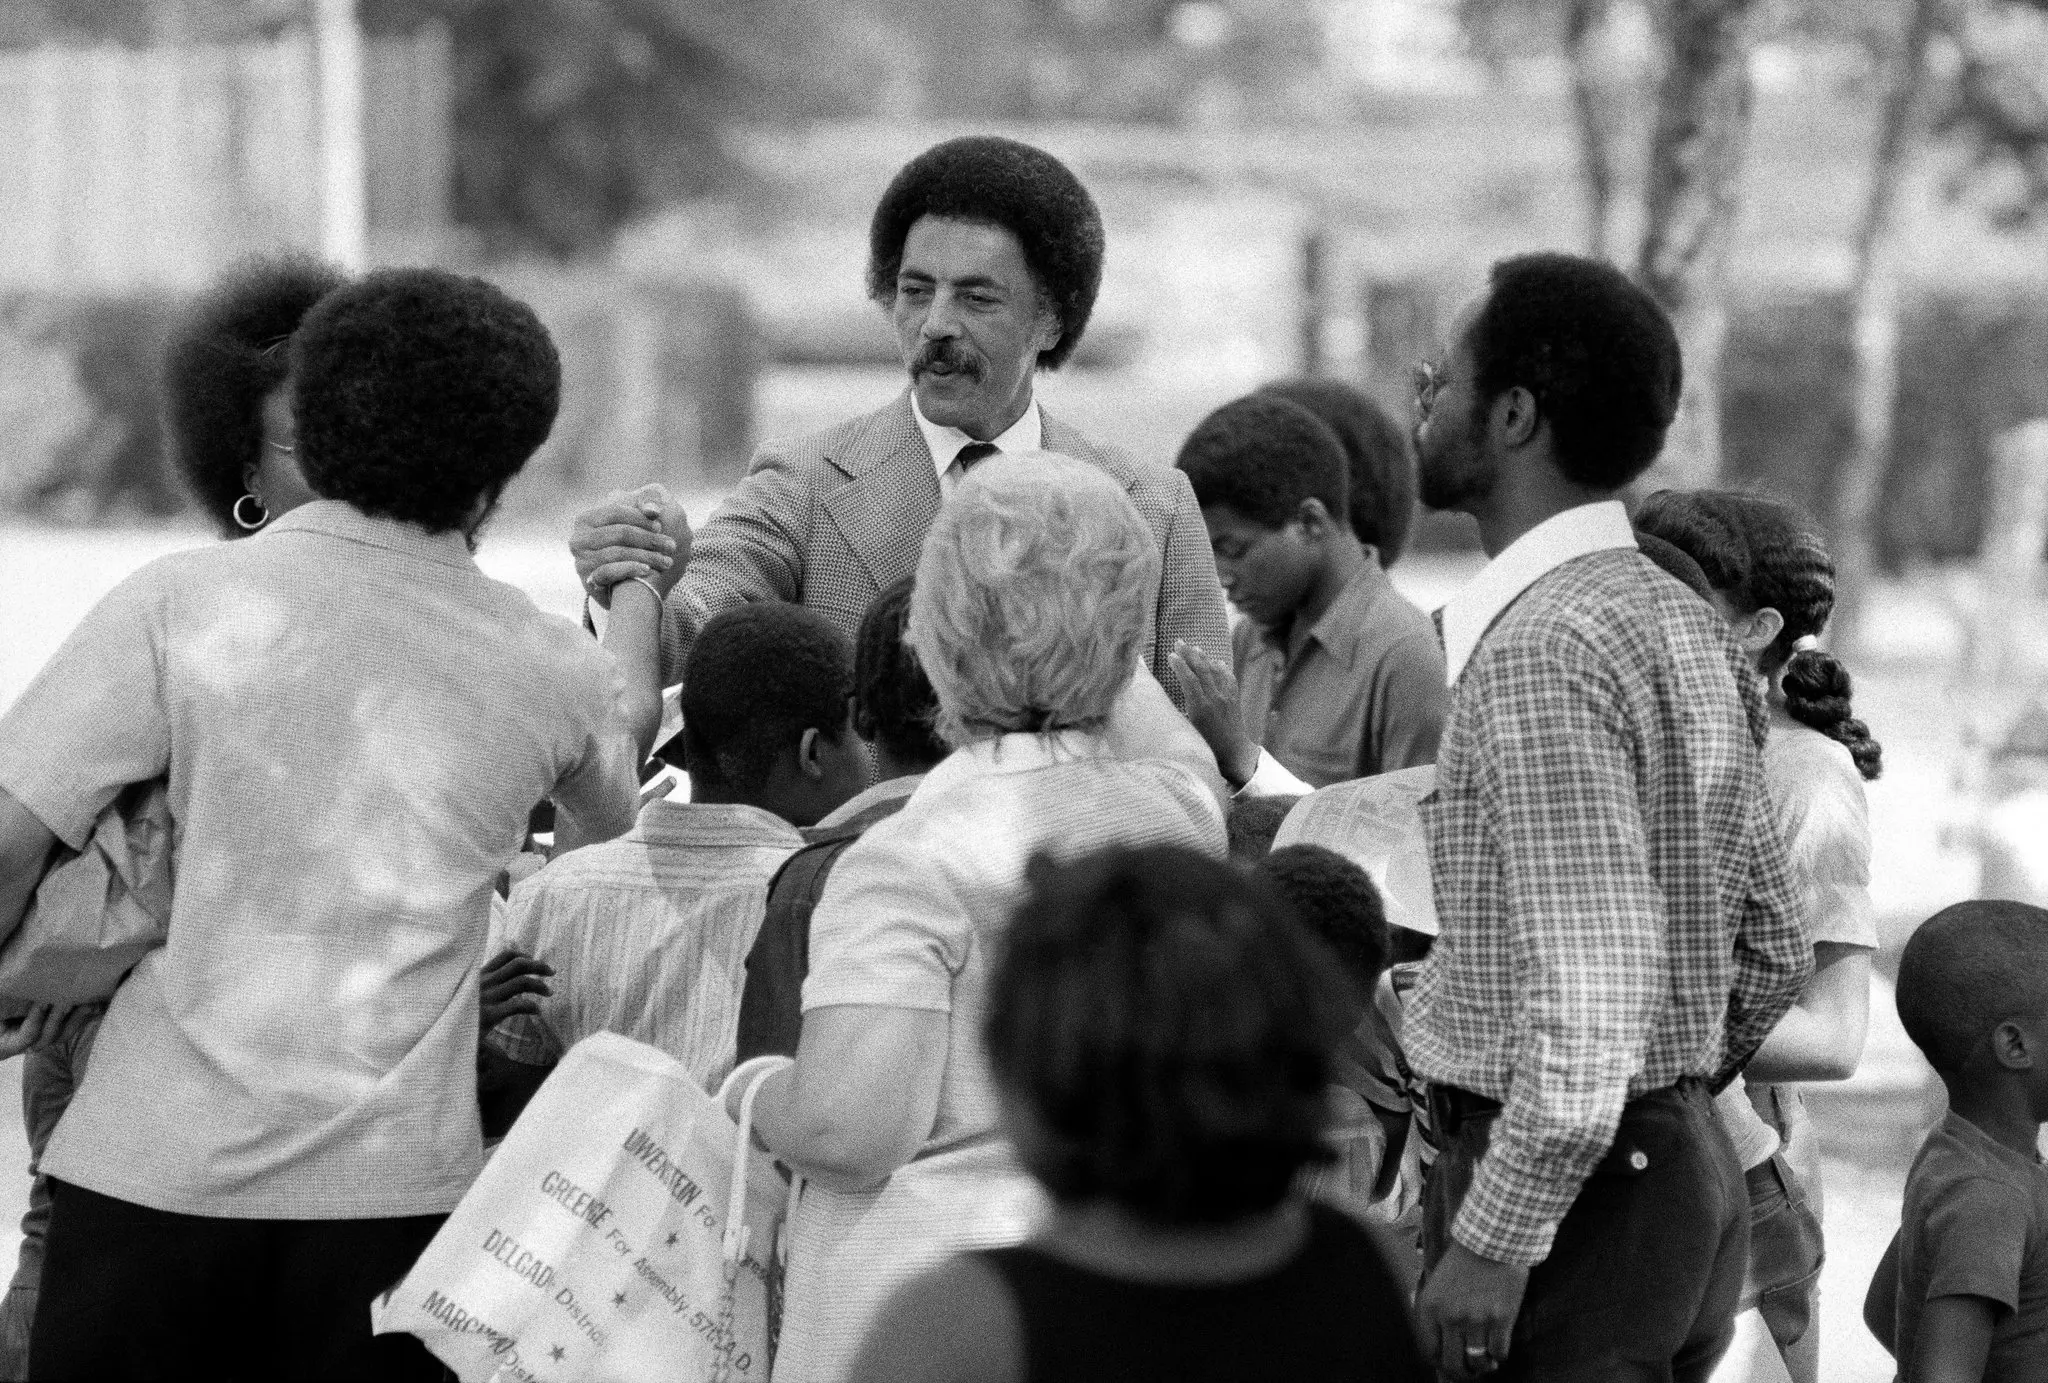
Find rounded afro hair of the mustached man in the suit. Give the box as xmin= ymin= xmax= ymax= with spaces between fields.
xmin=868 ymin=135 xmax=1102 ymax=369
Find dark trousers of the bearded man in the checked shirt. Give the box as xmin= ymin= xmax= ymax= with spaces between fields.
xmin=1423 ymin=1082 xmax=1749 ymax=1383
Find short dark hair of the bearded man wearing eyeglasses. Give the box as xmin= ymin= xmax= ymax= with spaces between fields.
xmin=1468 ymin=254 xmax=1683 ymax=490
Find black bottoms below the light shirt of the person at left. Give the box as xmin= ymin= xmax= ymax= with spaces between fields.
xmin=29 ymin=1180 xmax=444 ymax=1383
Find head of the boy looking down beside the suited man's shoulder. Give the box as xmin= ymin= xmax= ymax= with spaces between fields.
xmin=1174 ymin=393 xmax=1358 ymax=629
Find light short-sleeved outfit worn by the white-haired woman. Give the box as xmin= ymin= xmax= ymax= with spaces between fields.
xmin=776 ymin=734 xmax=1225 ymax=1383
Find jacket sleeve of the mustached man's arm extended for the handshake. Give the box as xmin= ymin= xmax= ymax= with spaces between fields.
xmin=662 ymin=451 xmax=815 ymax=686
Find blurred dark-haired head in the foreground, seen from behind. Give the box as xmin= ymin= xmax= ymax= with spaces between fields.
xmin=985 ymin=846 xmax=1356 ymax=1225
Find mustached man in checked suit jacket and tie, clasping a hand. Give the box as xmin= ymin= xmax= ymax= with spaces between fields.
xmin=569 ymin=135 xmax=1229 ymax=725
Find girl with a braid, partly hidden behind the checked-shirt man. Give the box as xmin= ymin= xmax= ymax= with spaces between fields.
xmin=1634 ymin=490 xmax=1882 ymax=1383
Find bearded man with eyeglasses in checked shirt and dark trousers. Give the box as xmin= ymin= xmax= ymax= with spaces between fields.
xmin=1403 ymin=254 xmax=1808 ymax=1381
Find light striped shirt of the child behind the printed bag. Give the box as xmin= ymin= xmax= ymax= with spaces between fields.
xmin=487 ymin=801 xmax=803 ymax=1090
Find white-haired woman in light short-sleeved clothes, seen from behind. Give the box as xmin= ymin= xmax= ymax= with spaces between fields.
xmin=727 ymin=453 xmax=1223 ymax=1383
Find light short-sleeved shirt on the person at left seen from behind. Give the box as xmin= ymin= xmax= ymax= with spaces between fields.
xmin=0 ymin=500 xmax=635 ymax=1219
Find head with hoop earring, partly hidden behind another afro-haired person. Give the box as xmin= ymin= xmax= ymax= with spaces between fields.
xmin=164 ymin=256 xmax=348 ymax=537
